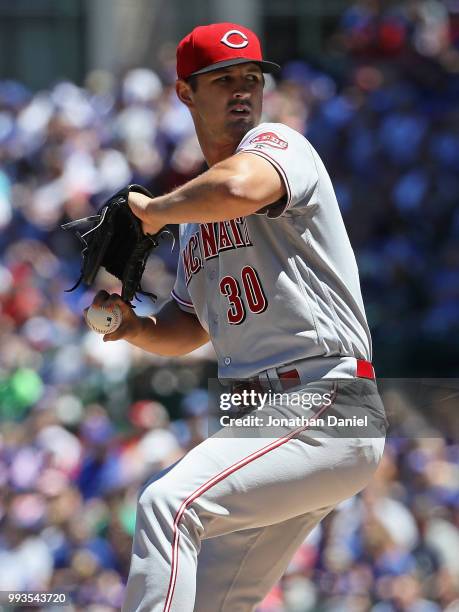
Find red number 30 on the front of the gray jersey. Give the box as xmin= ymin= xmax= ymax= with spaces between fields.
xmin=220 ymin=266 xmax=268 ymax=325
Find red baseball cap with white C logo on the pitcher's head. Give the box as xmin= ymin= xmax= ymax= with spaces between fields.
xmin=177 ymin=23 xmax=280 ymax=79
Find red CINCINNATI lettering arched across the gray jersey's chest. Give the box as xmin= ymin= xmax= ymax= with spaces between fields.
xmin=182 ymin=217 xmax=253 ymax=285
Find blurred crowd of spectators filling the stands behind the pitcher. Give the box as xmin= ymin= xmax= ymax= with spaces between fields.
xmin=0 ymin=0 xmax=459 ymax=612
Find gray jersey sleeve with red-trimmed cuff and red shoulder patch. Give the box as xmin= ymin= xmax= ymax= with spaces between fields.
xmin=236 ymin=123 xmax=318 ymax=218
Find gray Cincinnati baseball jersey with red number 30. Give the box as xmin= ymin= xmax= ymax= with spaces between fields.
xmin=172 ymin=123 xmax=371 ymax=379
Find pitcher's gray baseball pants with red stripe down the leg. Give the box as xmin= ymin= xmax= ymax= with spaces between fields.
xmin=122 ymin=378 xmax=387 ymax=612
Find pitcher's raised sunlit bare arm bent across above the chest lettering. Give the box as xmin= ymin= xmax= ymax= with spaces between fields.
xmin=129 ymin=153 xmax=285 ymax=233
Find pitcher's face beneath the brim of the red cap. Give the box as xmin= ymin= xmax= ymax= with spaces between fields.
xmin=181 ymin=63 xmax=264 ymax=144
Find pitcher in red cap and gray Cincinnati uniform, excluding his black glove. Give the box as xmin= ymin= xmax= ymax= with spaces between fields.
xmin=86 ymin=23 xmax=386 ymax=612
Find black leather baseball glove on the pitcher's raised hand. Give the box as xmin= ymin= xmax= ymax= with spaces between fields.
xmin=61 ymin=185 xmax=172 ymax=303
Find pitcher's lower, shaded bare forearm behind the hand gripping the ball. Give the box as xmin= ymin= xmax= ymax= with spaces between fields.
xmin=120 ymin=302 xmax=209 ymax=357
